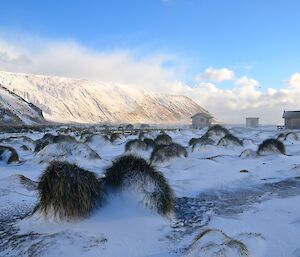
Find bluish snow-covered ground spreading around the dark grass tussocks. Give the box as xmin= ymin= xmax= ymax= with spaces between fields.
xmin=0 ymin=127 xmax=300 ymax=257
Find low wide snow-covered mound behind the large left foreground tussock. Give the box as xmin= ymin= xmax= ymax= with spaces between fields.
xmin=36 ymin=142 xmax=101 ymax=163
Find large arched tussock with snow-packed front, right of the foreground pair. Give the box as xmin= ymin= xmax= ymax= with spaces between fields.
xmin=104 ymin=155 xmax=173 ymax=215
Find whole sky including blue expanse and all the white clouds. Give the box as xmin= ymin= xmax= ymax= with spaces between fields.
xmin=0 ymin=0 xmax=300 ymax=124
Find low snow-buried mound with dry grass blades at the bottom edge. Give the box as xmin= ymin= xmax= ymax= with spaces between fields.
xmin=184 ymin=229 xmax=264 ymax=257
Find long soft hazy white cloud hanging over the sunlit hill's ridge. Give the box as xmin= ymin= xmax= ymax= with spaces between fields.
xmin=0 ymin=39 xmax=176 ymax=90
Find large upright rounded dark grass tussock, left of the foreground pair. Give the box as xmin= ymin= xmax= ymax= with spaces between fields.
xmin=36 ymin=161 xmax=104 ymax=220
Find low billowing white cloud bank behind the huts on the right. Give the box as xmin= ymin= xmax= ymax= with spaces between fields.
xmin=166 ymin=73 xmax=300 ymax=124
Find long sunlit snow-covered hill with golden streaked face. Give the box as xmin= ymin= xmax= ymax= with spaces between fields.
xmin=0 ymin=72 xmax=206 ymax=124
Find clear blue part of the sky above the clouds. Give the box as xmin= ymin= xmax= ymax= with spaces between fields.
xmin=0 ymin=0 xmax=300 ymax=88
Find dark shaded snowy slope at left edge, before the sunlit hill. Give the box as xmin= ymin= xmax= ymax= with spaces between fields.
xmin=0 ymin=83 xmax=44 ymax=125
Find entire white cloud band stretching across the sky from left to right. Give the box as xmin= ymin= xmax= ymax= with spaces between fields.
xmin=0 ymin=35 xmax=300 ymax=124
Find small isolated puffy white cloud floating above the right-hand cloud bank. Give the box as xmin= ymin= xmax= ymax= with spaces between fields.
xmin=196 ymin=67 xmax=235 ymax=82
